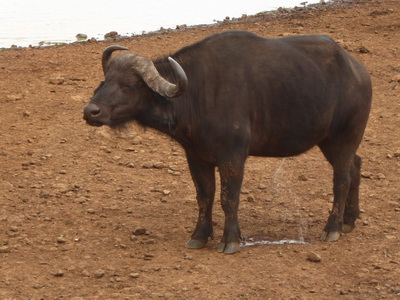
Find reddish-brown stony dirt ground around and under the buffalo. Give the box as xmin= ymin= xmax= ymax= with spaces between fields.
xmin=0 ymin=0 xmax=400 ymax=300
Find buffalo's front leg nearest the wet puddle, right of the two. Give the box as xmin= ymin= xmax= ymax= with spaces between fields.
xmin=217 ymin=159 xmax=245 ymax=254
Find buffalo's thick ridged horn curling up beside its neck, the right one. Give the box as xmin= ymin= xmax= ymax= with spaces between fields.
xmin=132 ymin=56 xmax=188 ymax=98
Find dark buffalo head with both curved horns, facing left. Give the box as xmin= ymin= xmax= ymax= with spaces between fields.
xmin=83 ymin=46 xmax=187 ymax=127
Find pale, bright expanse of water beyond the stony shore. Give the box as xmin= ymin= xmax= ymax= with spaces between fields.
xmin=0 ymin=0 xmax=319 ymax=48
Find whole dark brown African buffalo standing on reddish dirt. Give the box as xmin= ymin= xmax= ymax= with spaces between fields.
xmin=84 ymin=31 xmax=372 ymax=253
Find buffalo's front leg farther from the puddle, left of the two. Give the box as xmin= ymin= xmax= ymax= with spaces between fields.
xmin=186 ymin=154 xmax=215 ymax=249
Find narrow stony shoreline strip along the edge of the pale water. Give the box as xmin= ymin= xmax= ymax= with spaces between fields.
xmin=0 ymin=0 xmax=356 ymax=51
